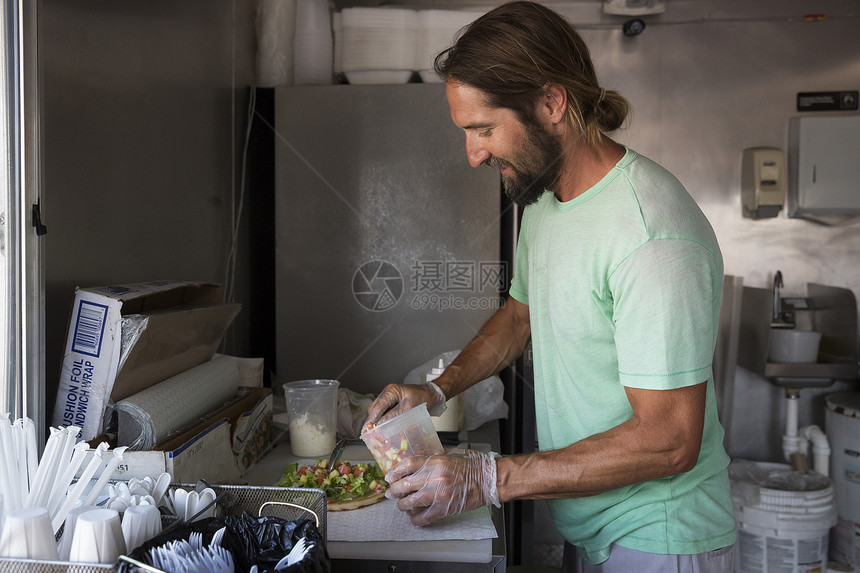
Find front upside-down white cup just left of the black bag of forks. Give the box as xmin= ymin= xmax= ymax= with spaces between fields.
xmin=69 ymin=509 xmax=126 ymax=564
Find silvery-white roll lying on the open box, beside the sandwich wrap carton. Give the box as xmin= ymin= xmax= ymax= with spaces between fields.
xmin=114 ymin=357 xmax=239 ymax=450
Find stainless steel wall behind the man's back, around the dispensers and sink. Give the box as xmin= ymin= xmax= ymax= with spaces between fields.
xmin=552 ymin=0 xmax=860 ymax=461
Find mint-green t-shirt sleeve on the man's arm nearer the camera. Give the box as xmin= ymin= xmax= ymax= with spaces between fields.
xmin=610 ymin=239 xmax=722 ymax=389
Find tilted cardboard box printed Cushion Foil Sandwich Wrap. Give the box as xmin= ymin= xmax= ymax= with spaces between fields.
xmin=52 ymin=281 xmax=241 ymax=440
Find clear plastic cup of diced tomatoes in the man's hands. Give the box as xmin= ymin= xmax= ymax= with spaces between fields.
xmin=361 ymin=404 xmax=445 ymax=473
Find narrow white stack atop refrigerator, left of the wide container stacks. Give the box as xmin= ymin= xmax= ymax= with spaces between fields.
xmin=293 ymin=0 xmax=332 ymax=84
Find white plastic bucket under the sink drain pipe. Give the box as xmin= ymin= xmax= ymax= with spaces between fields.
xmin=729 ymin=461 xmax=836 ymax=573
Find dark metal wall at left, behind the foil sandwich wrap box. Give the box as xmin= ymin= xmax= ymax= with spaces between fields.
xmin=39 ymin=0 xmax=254 ymax=411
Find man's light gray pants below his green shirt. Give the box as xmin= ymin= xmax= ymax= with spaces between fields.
xmin=562 ymin=543 xmax=735 ymax=573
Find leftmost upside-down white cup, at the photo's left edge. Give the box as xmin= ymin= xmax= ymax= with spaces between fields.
xmin=0 ymin=507 xmax=57 ymax=561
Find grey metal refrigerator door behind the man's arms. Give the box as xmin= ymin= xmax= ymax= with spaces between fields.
xmin=275 ymin=84 xmax=510 ymax=393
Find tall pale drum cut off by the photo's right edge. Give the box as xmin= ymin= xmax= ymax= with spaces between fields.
xmin=825 ymin=392 xmax=860 ymax=568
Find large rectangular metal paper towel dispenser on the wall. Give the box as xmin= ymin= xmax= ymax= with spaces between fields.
xmin=788 ymin=116 xmax=860 ymax=217
